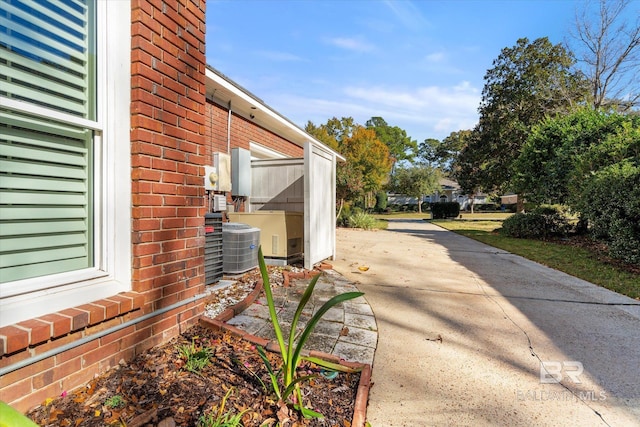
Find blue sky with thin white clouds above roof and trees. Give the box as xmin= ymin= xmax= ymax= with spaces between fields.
xmin=206 ymin=0 xmax=582 ymax=142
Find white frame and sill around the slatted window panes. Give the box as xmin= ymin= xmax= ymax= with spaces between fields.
xmin=0 ymin=0 xmax=132 ymax=327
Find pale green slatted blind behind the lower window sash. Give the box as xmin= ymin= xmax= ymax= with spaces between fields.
xmin=0 ymin=110 xmax=93 ymax=282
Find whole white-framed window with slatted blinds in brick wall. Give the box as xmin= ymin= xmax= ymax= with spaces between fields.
xmin=0 ymin=0 xmax=131 ymax=325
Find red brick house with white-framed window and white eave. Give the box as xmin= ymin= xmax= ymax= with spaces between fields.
xmin=0 ymin=0 xmax=341 ymax=411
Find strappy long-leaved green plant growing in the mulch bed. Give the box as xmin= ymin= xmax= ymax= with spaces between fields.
xmin=258 ymin=248 xmax=364 ymax=418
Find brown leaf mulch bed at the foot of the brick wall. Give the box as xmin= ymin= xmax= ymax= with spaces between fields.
xmin=27 ymin=325 xmax=360 ymax=427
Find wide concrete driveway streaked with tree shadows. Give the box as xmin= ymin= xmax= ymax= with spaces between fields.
xmin=333 ymin=220 xmax=640 ymax=427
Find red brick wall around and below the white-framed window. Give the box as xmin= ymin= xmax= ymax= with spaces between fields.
xmin=0 ymin=0 xmax=208 ymax=411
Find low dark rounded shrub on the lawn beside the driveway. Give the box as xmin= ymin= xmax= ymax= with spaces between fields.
xmin=500 ymin=205 xmax=570 ymax=239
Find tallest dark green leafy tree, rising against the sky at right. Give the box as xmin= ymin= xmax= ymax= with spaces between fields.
xmin=463 ymin=37 xmax=586 ymax=191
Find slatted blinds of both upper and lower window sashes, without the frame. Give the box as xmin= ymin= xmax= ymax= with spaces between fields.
xmin=0 ymin=0 xmax=96 ymax=283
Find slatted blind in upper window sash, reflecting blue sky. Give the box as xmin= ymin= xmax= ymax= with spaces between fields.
xmin=0 ymin=0 xmax=95 ymax=119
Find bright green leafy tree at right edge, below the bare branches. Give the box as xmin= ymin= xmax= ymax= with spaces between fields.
xmin=514 ymin=107 xmax=640 ymax=205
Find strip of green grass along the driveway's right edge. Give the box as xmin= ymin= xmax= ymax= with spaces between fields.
xmin=432 ymin=219 xmax=640 ymax=299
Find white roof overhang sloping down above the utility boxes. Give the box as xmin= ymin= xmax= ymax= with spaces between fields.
xmin=206 ymin=65 xmax=346 ymax=161
